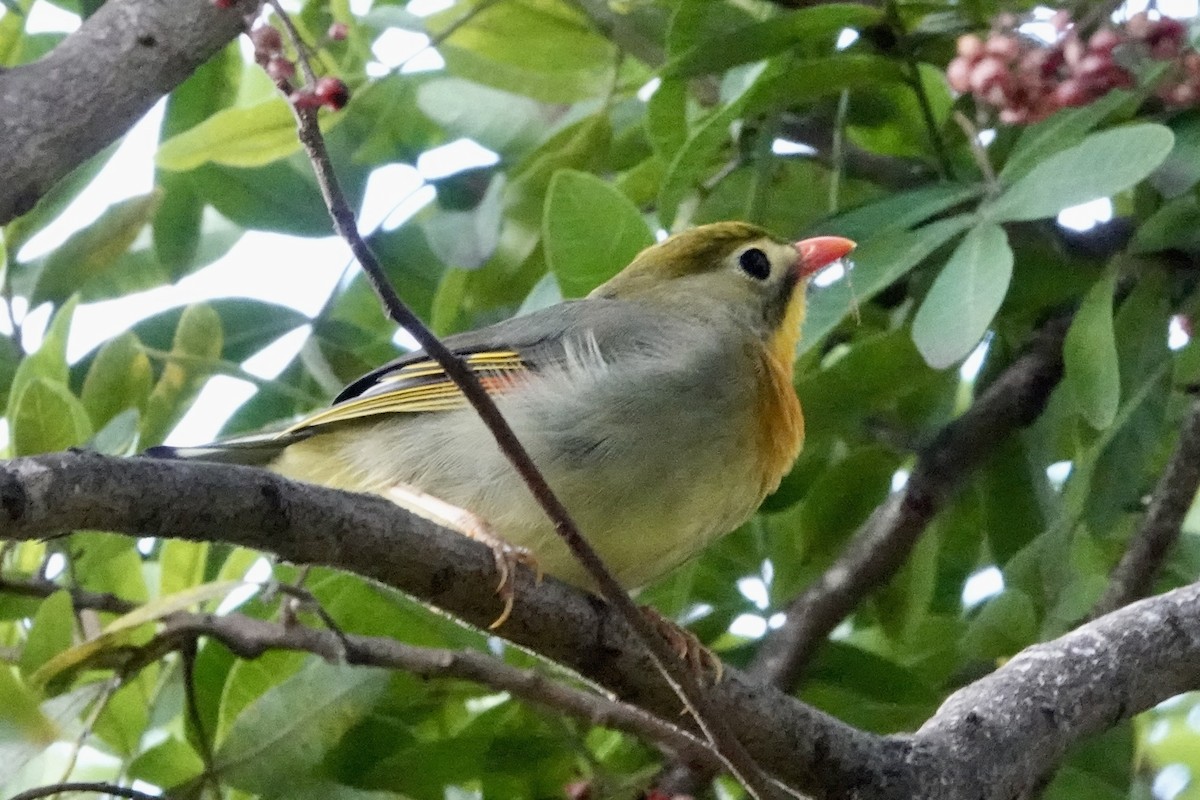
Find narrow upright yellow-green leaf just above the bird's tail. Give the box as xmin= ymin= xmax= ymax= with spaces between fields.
xmin=142 ymin=303 xmax=222 ymax=445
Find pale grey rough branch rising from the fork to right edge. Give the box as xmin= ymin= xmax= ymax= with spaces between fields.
xmin=910 ymin=584 xmax=1200 ymax=800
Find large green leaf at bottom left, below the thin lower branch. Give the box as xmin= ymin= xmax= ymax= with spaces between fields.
xmin=215 ymin=658 xmax=389 ymax=795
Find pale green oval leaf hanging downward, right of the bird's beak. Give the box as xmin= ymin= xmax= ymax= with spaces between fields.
xmin=912 ymin=223 xmax=1013 ymax=369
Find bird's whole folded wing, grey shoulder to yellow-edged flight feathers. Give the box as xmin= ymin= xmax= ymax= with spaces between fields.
xmin=284 ymin=300 xmax=636 ymax=434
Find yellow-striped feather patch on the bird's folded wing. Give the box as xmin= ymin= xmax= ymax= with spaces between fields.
xmin=280 ymin=350 xmax=529 ymax=435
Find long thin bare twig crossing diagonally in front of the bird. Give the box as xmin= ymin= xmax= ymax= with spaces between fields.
xmin=264 ymin=7 xmax=778 ymax=800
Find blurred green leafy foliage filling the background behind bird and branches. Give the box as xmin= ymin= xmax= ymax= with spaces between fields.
xmin=0 ymin=0 xmax=1200 ymax=800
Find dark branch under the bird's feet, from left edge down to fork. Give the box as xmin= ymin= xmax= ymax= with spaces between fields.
xmin=0 ymin=452 xmax=893 ymax=790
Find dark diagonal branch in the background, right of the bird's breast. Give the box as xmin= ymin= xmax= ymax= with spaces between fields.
xmin=750 ymin=318 xmax=1070 ymax=688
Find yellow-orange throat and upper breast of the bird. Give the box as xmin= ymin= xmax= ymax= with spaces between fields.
xmin=757 ymin=291 xmax=804 ymax=497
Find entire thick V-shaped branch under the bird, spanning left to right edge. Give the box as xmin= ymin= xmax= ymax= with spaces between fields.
xmin=7 ymin=453 xmax=1200 ymax=800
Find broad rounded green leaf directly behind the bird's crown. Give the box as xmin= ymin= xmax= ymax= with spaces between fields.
xmin=542 ymin=169 xmax=654 ymax=297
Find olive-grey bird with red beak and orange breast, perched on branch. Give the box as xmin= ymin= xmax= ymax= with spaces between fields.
xmin=148 ymin=222 xmax=854 ymax=621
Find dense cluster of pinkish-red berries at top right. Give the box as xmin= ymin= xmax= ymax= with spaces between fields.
xmin=946 ymin=11 xmax=1200 ymax=125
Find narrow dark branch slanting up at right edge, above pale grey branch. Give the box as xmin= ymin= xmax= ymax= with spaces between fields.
xmin=1091 ymin=399 xmax=1200 ymax=619
